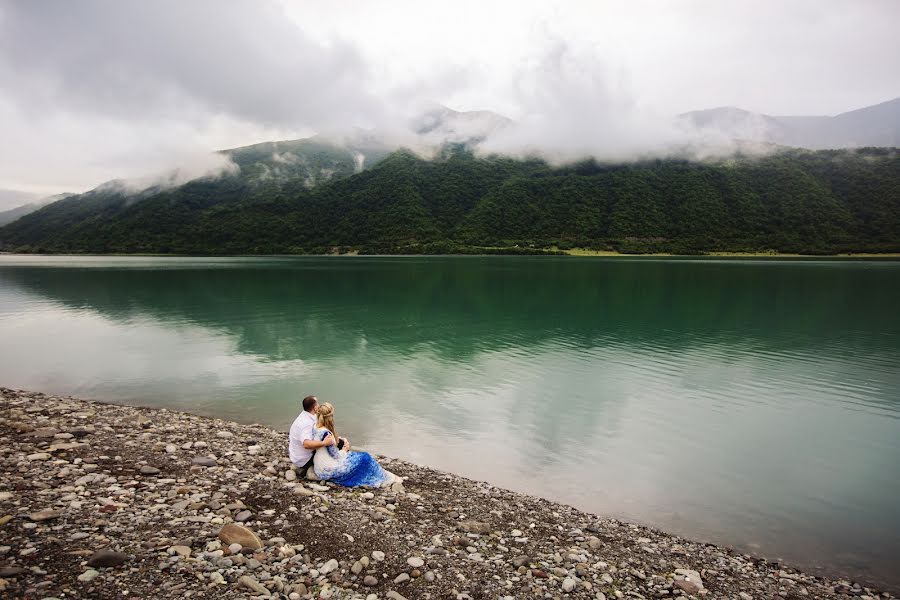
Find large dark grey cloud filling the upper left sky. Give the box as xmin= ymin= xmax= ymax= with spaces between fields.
xmin=0 ymin=0 xmax=380 ymax=127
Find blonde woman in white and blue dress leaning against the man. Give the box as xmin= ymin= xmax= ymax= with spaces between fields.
xmin=313 ymin=402 xmax=399 ymax=487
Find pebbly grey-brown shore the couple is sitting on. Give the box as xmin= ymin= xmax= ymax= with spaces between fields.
xmin=0 ymin=388 xmax=892 ymax=600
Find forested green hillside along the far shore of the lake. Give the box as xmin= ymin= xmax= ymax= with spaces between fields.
xmin=0 ymin=148 xmax=900 ymax=254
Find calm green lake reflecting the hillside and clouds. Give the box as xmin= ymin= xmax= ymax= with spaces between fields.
xmin=0 ymin=255 xmax=900 ymax=590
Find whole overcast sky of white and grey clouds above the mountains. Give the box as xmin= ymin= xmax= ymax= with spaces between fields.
xmin=0 ymin=0 xmax=900 ymax=202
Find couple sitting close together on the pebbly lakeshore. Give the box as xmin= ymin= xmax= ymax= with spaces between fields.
xmin=288 ymin=396 xmax=400 ymax=487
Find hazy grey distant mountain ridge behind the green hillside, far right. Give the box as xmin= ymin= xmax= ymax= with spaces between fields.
xmin=679 ymin=98 xmax=900 ymax=149
